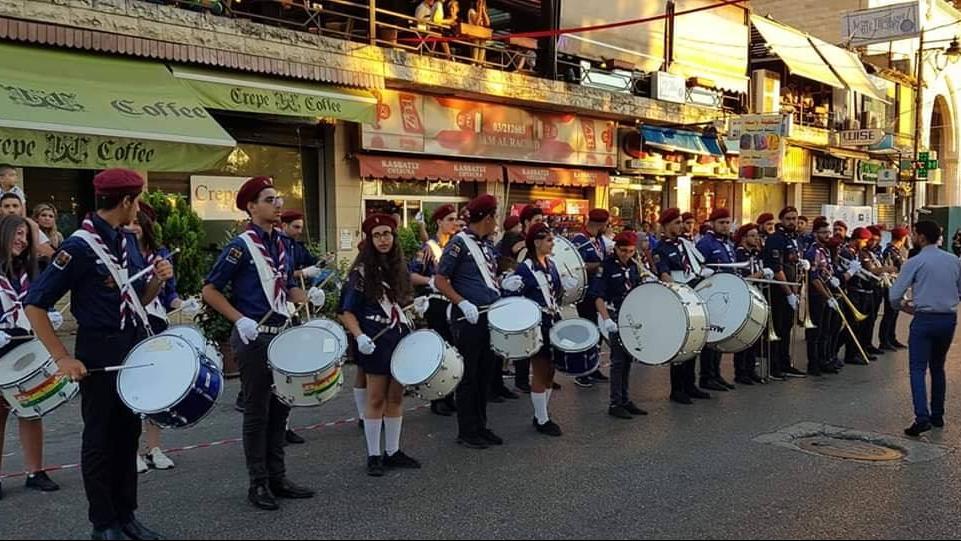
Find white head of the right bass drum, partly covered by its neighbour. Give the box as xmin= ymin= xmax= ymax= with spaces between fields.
xmin=694 ymin=273 xmax=751 ymax=344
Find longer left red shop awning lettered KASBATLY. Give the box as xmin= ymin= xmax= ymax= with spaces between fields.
xmin=357 ymin=156 xmax=504 ymax=182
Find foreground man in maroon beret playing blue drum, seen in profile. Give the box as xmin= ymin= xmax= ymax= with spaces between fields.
xmin=26 ymin=169 xmax=173 ymax=539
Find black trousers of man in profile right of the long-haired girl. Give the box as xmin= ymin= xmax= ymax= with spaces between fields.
xmin=451 ymin=306 xmax=501 ymax=437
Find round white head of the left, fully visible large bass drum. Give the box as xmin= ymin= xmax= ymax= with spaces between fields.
xmin=617 ymin=282 xmax=689 ymax=365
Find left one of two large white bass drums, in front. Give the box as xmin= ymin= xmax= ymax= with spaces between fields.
xmin=617 ymin=282 xmax=708 ymax=366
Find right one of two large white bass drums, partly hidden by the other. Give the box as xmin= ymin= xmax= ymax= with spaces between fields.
xmin=694 ymin=273 xmax=770 ymax=353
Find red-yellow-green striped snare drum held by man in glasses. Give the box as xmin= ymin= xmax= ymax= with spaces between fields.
xmin=267 ymin=325 xmax=344 ymax=408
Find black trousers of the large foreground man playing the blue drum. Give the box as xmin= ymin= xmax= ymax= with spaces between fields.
xmin=76 ymin=326 xmax=141 ymax=530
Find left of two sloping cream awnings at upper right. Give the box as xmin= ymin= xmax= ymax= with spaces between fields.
xmin=751 ymin=15 xmax=845 ymax=88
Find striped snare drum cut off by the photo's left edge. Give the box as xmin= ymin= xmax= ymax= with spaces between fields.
xmin=0 ymin=340 xmax=80 ymax=419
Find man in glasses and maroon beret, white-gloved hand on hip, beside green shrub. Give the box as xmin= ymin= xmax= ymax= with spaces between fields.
xmin=203 ymin=177 xmax=325 ymax=511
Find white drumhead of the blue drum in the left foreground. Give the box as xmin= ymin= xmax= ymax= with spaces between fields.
xmin=118 ymin=334 xmax=200 ymax=413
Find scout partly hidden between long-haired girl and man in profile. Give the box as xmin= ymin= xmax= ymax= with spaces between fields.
xmin=409 ymin=204 xmax=461 ymax=417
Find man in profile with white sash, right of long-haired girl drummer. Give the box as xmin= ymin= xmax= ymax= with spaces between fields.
xmin=434 ymin=195 xmax=504 ymax=449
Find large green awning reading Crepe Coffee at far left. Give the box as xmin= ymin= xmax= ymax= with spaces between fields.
xmin=0 ymin=44 xmax=236 ymax=172
